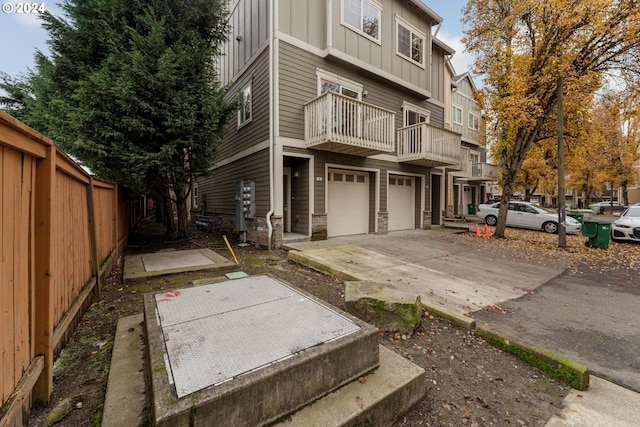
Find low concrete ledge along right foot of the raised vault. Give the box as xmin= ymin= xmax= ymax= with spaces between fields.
xmin=278 ymin=346 xmax=426 ymax=427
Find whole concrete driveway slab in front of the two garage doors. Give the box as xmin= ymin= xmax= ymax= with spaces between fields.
xmin=286 ymin=229 xmax=563 ymax=314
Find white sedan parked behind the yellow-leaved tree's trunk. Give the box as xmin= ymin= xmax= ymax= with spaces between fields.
xmin=476 ymin=201 xmax=582 ymax=234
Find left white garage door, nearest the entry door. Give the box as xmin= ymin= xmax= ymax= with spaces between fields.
xmin=327 ymin=169 xmax=369 ymax=236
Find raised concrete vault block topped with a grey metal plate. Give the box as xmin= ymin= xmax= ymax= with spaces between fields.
xmin=145 ymin=276 xmax=379 ymax=426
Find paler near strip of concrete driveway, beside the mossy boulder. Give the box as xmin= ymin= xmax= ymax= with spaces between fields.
xmin=289 ymin=245 xmax=525 ymax=314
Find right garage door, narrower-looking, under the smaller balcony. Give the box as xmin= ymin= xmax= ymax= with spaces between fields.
xmin=387 ymin=175 xmax=416 ymax=231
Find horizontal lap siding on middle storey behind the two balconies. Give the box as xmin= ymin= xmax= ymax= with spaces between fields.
xmin=279 ymin=38 xmax=444 ymax=139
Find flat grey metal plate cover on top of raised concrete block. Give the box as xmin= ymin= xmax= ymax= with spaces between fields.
xmin=154 ymin=276 xmax=360 ymax=398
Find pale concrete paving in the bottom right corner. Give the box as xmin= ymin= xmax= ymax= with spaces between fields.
xmin=545 ymin=376 xmax=640 ymax=427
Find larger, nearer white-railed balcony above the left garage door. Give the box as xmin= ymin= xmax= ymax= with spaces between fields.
xmin=304 ymin=92 xmax=395 ymax=157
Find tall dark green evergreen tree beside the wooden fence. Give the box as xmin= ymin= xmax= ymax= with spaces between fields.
xmin=0 ymin=0 xmax=236 ymax=236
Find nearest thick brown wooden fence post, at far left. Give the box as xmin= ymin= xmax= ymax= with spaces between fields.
xmin=33 ymin=145 xmax=57 ymax=403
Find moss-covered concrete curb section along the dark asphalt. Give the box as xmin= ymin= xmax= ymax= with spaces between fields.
xmin=476 ymin=324 xmax=589 ymax=390
